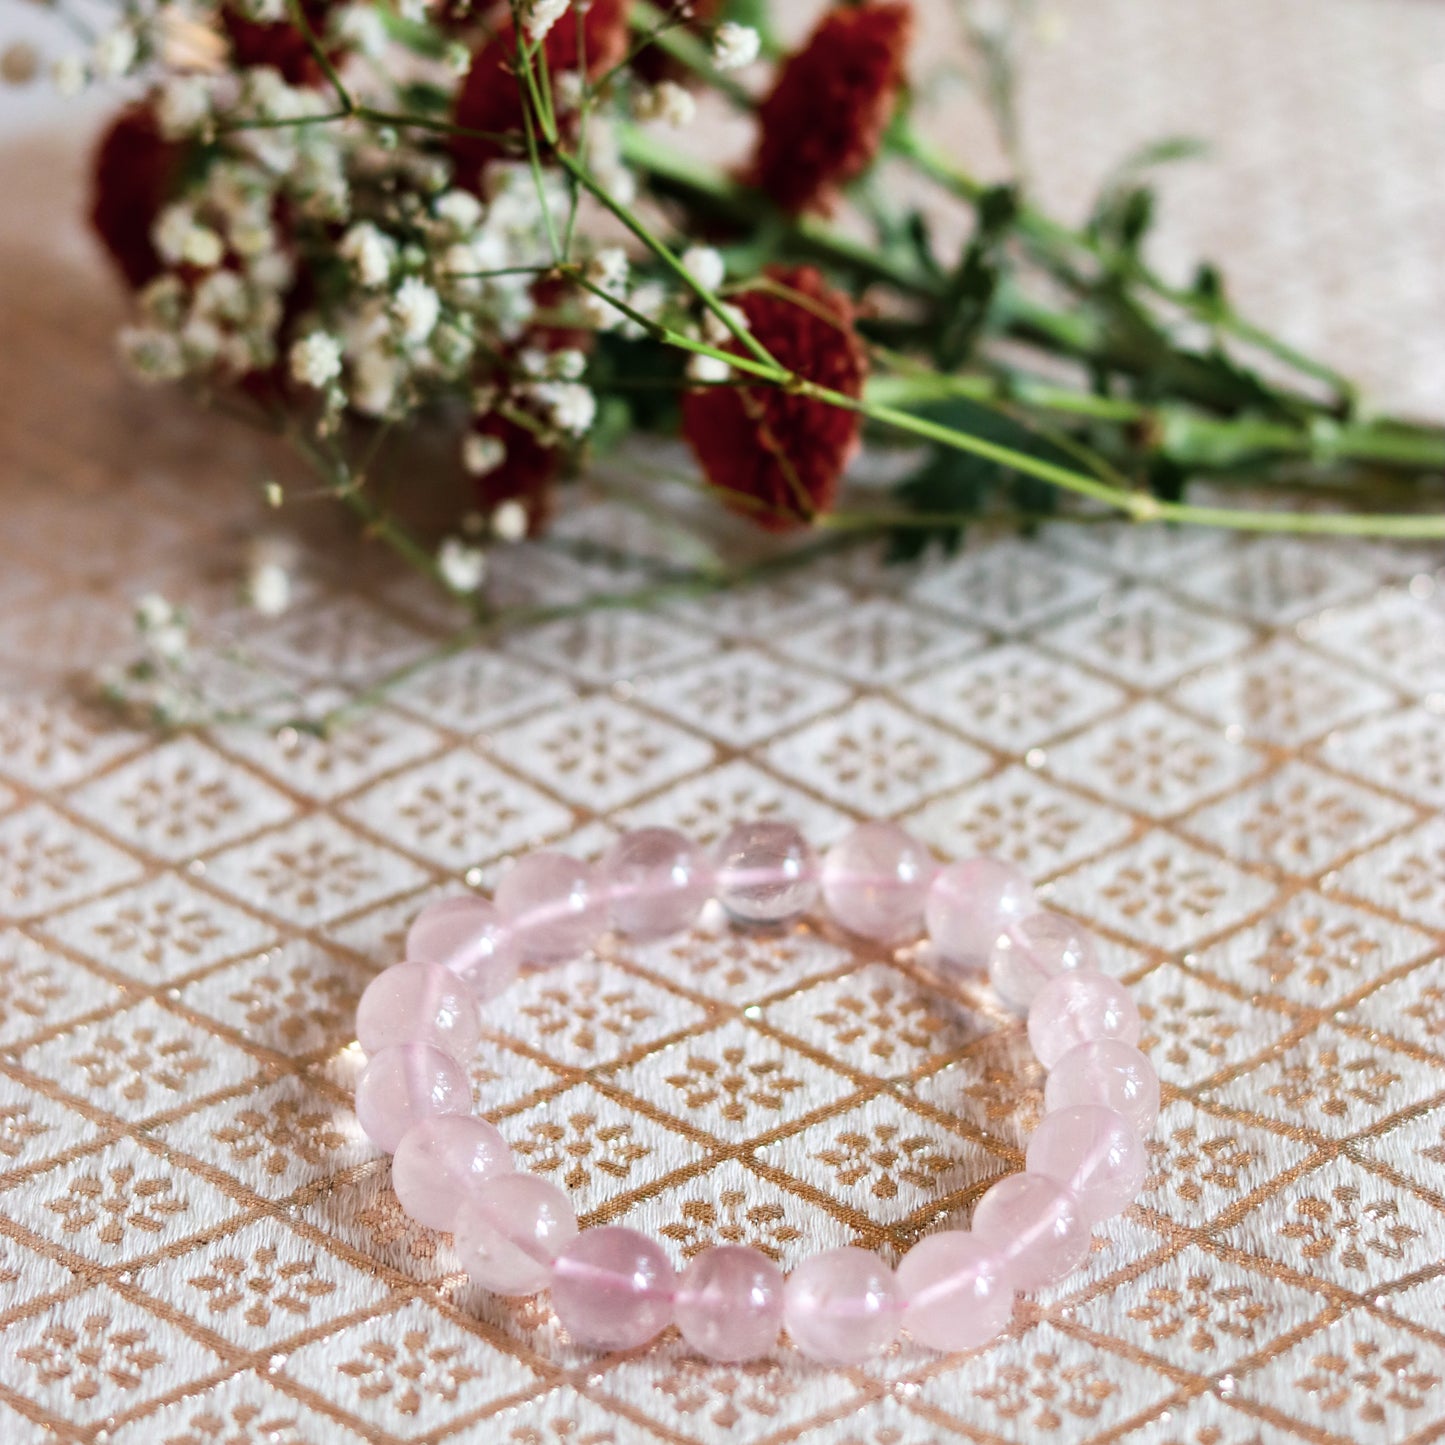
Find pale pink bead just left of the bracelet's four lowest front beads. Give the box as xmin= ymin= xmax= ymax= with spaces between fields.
xmin=452 ymin=1173 xmax=577 ymax=1295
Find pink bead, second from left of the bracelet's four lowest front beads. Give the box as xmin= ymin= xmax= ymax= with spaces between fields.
xmin=673 ymin=1244 xmax=783 ymax=1363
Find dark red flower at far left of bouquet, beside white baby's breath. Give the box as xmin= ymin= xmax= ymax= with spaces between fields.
xmin=91 ymin=103 xmax=185 ymax=290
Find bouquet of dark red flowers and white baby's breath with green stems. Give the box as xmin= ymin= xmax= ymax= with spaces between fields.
xmin=36 ymin=0 xmax=1445 ymax=676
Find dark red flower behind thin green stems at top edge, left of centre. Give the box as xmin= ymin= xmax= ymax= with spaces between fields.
xmin=451 ymin=0 xmax=631 ymax=189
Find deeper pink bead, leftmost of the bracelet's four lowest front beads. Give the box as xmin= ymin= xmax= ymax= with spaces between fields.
xmin=552 ymin=1224 xmax=678 ymax=1350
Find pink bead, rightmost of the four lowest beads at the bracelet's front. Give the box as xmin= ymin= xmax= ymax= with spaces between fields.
xmin=897 ymin=1230 xmax=1013 ymax=1351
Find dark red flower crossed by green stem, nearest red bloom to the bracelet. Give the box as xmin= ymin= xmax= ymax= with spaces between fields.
xmin=682 ymin=266 xmax=868 ymax=532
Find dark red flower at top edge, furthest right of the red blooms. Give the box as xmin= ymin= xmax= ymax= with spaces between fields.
xmin=753 ymin=3 xmax=913 ymax=212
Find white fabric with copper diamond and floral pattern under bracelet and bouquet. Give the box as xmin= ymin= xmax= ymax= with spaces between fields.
xmin=8 ymin=0 xmax=1445 ymax=1445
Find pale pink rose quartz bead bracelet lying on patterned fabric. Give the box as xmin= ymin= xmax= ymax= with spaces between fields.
xmin=355 ymin=822 xmax=1159 ymax=1364
